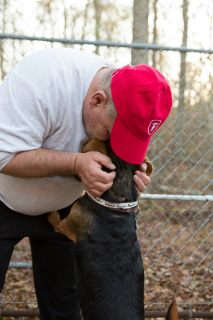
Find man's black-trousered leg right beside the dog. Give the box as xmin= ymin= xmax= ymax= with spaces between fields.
xmin=30 ymin=210 xmax=80 ymax=320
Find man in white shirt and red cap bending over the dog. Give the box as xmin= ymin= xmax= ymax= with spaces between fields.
xmin=0 ymin=49 xmax=171 ymax=320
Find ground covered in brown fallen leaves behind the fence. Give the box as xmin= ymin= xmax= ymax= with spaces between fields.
xmin=0 ymin=202 xmax=213 ymax=319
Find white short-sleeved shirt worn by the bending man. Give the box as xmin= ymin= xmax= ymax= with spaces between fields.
xmin=0 ymin=48 xmax=112 ymax=215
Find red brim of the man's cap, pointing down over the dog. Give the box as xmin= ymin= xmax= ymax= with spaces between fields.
xmin=110 ymin=116 xmax=150 ymax=164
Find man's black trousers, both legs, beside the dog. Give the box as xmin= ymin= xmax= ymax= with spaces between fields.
xmin=0 ymin=202 xmax=80 ymax=320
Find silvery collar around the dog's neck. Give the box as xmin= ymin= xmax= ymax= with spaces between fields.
xmin=85 ymin=190 xmax=139 ymax=214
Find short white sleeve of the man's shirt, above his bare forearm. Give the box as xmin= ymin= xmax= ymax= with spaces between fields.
xmin=0 ymin=72 xmax=47 ymax=170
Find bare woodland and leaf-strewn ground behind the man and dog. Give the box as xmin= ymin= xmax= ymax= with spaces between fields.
xmin=0 ymin=0 xmax=213 ymax=319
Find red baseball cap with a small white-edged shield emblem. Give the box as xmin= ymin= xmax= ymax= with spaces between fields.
xmin=110 ymin=64 xmax=172 ymax=164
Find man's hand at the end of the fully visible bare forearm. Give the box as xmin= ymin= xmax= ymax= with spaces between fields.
xmin=74 ymin=151 xmax=115 ymax=197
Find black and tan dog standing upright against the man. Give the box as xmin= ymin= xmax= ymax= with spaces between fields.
xmin=49 ymin=140 xmax=152 ymax=320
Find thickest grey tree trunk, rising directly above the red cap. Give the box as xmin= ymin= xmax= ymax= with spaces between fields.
xmin=132 ymin=0 xmax=149 ymax=65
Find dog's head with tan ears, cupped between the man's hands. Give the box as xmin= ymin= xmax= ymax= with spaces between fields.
xmin=82 ymin=139 xmax=153 ymax=202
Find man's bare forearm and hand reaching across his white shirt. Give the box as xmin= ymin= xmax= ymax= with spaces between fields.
xmin=1 ymin=148 xmax=115 ymax=196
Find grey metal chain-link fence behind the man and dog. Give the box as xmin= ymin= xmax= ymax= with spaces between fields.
xmin=0 ymin=35 xmax=213 ymax=319
